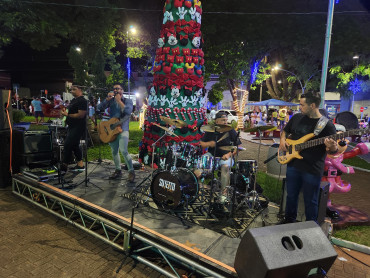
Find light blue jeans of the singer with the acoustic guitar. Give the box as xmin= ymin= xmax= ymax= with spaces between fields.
xmin=109 ymin=131 xmax=134 ymax=171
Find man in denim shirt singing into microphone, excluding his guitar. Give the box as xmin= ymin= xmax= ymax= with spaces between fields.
xmin=98 ymin=84 xmax=135 ymax=182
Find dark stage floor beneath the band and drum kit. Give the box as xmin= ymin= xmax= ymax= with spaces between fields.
xmin=25 ymin=161 xmax=279 ymax=272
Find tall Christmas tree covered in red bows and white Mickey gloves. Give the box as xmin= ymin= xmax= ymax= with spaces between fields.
xmin=140 ymin=0 xmax=207 ymax=165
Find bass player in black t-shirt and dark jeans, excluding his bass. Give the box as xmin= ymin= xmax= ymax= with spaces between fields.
xmin=279 ymin=92 xmax=338 ymax=223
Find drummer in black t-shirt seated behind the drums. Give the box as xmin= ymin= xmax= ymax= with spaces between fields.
xmin=200 ymin=112 xmax=241 ymax=203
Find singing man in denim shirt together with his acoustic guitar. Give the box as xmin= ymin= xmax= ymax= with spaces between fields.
xmin=98 ymin=84 xmax=135 ymax=182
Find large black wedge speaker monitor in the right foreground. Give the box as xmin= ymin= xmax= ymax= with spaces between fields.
xmin=234 ymin=221 xmax=337 ymax=278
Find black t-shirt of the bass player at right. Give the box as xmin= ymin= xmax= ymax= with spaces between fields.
xmin=284 ymin=114 xmax=336 ymax=176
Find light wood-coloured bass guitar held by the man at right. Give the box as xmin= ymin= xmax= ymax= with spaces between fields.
xmin=278 ymin=128 xmax=369 ymax=164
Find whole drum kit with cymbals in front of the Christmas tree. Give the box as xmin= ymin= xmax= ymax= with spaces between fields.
xmin=138 ymin=116 xmax=266 ymax=217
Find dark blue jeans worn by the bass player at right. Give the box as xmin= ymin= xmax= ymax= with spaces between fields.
xmin=285 ymin=166 xmax=321 ymax=222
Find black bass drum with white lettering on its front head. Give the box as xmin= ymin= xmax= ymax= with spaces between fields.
xmin=150 ymin=168 xmax=199 ymax=209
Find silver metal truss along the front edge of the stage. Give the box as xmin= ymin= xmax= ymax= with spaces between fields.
xmin=12 ymin=174 xmax=237 ymax=277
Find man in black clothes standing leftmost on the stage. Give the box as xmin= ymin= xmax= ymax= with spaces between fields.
xmin=60 ymin=85 xmax=87 ymax=172
